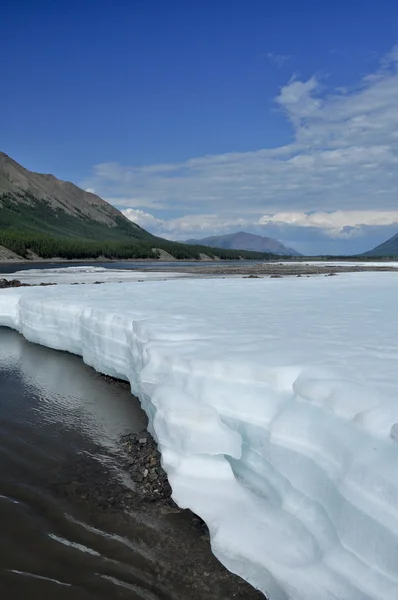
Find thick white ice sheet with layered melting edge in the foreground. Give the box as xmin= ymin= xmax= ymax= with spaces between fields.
xmin=0 ymin=273 xmax=398 ymax=600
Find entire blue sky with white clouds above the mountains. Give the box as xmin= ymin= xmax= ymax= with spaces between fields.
xmin=0 ymin=0 xmax=398 ymax=254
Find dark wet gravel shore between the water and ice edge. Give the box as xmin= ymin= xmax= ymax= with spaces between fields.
xmin=53 ymin=420 xmax=266 ymax=600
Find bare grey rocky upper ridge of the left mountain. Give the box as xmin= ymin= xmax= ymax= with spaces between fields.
xmin=0 ymin=152 xmax=138 ymax=227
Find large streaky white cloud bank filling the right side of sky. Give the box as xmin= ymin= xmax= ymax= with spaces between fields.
xmin=84 ymin=46 xmax=398 ymax=253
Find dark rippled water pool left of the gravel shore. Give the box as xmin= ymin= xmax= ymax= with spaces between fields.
xmin=0 ymin=328 xmax=152 ymax=599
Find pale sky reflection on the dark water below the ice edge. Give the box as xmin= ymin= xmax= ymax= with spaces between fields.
xmin=0 ymin=329 xmax=146 ymax=444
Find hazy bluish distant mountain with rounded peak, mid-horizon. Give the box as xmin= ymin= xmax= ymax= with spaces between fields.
xmin=185 ymin=231 xmax=301 ymax=256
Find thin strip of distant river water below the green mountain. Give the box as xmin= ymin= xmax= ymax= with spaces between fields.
xmin=0 ymin=260 xmax=258 ymax=274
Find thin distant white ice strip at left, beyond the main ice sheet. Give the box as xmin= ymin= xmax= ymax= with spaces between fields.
xmin=0 ymin=266 xmax=189 ymax=285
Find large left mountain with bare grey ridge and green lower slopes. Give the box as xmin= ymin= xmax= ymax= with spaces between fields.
xmin=0 ymin=152 xmax=276 ymax=260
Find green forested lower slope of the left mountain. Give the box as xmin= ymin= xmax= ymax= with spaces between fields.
xmin=0 ymin=192 xmax=276 ymax=259
